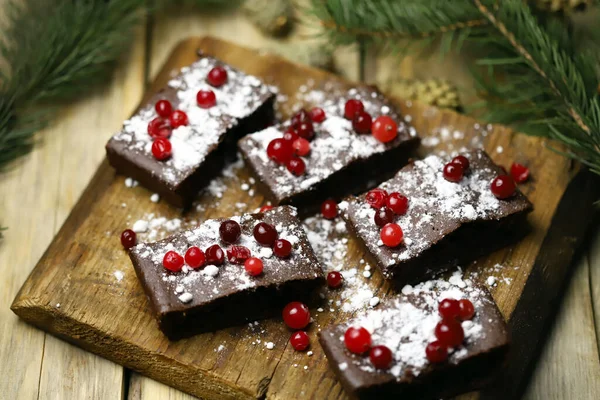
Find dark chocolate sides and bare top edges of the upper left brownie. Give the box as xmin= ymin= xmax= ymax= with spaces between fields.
xmin=106 ymin=56 xmax=275 ymax=207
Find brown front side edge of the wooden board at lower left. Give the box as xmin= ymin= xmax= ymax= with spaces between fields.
xmin=11 ymin=298 xmax=255 ymax=400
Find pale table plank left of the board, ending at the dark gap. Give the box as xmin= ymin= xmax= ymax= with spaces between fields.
xmin=0 ymin=24 xmax=145 ymax=399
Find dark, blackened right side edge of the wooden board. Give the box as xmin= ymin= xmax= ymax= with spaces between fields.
xmin=479 ymin=169 xmax=600 ymax=400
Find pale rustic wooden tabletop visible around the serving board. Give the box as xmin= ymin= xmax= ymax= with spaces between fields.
xmin=0 ymin=7 xmax=600 ymax=400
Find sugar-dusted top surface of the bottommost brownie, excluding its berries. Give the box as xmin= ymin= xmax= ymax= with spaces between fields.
xmin=321 ymin=271 xmax=508 ymax=387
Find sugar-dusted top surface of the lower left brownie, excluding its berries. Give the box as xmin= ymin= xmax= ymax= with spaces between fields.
xmin=130 ymin=206 xmax=323 ymax=313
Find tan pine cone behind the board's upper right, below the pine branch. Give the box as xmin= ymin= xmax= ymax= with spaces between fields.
xmin=387 ymin=79 xmax=461 ymax=110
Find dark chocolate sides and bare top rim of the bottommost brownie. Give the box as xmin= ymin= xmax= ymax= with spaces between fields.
xmin=319 ymin=287 xmax=509 ymax=400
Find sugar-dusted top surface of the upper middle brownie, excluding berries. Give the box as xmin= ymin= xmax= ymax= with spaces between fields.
xmin=239 ymin=87 xmax=417 ymax=201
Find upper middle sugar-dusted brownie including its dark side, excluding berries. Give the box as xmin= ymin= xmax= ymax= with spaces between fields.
xmin=238 ymin=87 xmax=419 ymax=215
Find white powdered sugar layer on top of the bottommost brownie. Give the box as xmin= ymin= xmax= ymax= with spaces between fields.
xmin=340 ymin=270 xmax=491 ymax=378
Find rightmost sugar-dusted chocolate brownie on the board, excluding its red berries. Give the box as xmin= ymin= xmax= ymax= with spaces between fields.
xmin=339 ymin=150 xmax=532 ymax=287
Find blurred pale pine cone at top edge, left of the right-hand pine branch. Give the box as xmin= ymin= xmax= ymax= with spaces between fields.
xmin=242 ymin=0 xmax=294 ymax=36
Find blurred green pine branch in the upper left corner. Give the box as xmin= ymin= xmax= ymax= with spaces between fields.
xmin=0 ymin=0 xmax=238 ymax=172
